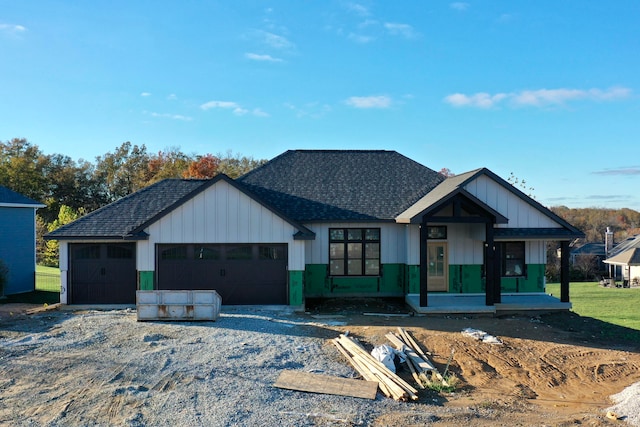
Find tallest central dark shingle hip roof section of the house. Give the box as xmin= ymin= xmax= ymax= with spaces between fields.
xmin=237 ymin=150 xmax=444 ymax=222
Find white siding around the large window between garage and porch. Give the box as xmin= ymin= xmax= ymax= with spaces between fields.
xmin=304 ymin=222 xmax=407 ymax=264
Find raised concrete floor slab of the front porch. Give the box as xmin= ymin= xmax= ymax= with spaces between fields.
xmin=405 ymin=292 xmax=571 ymax=316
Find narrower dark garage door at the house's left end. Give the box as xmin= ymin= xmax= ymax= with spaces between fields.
xmin=69 ymin=243 xmax=137 ymax=304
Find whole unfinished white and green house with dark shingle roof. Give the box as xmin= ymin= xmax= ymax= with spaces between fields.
xmin=47 ymin=150 xmax=583 ymax=309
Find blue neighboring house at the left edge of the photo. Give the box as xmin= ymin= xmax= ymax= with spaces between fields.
xmin=0 ymin=185 xmax=46 ymax=295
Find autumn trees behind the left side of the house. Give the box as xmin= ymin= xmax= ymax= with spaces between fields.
xmin=0 ymin=138 xmax=266 ymax=265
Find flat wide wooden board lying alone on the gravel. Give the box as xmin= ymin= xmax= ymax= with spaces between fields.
xmin=274 ymin=371 xmax=378 ymax=399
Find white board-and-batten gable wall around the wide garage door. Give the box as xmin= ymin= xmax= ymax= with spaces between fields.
xmin=137 ymin=180 xmax=304 ymax=271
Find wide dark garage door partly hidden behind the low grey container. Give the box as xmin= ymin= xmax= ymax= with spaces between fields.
xmin=156 ymin=243 xmax=287 ymax=305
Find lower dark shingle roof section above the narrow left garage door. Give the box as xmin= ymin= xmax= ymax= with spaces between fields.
xmin=46 ymin=179 xmax=211 ymax=239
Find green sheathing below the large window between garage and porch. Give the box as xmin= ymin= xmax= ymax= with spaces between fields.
xmin=304 ymin=264 xmax=406 ymax=296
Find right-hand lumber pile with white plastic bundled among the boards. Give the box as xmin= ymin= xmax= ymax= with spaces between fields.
xmin=385 ymin=328 xmax=449 ymax=388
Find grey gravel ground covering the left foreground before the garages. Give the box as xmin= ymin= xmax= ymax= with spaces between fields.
xmin=0 ymin=310 xmax=443 ymax=427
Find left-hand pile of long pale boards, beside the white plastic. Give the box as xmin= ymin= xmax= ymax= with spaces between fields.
xmin=332 ymin=334 xmax=418 ymax=401
